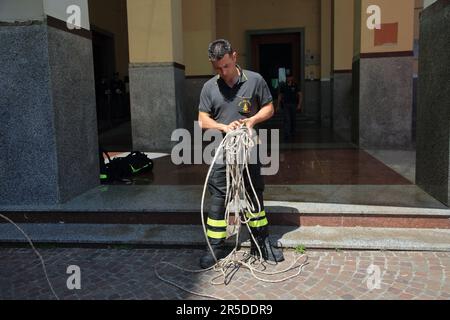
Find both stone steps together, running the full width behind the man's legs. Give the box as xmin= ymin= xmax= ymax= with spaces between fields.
xmin=0 ymin=186 xmax=450 ymax=251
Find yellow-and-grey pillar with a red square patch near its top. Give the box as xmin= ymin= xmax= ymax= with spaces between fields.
xmin=352 ymin=0 xmax=414 ymax=150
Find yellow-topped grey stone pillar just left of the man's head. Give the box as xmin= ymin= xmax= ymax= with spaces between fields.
xmin=127 ymin=0 xmax=187 ymax=151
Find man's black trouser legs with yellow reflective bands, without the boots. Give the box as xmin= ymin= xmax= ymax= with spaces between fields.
xmin=207 ymin=162 xmax=268 ymax=245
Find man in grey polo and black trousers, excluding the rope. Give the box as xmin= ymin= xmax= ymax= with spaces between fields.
xmin=199 ymin=39 xmax=284 ymax=269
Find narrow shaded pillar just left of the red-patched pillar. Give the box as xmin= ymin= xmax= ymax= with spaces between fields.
xmin=332 ymin=0 xmax=354 ymax=141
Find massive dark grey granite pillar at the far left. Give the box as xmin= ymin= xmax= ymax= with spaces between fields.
xmin=0 ymin=0 xmax=100 ymax=206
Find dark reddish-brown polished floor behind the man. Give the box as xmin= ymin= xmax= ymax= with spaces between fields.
xmin=104 ymin=149 xmax=412 ymax=185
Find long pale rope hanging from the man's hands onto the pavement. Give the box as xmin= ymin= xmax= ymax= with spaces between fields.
xmin=155 ymin=125 xmax=308 ymax=300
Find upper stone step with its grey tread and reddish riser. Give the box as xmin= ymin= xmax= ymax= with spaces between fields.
xmin=0 ymin=185 xmax=450 ymax=229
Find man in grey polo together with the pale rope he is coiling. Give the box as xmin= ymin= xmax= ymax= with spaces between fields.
xmin=155 ymin=39 xmax=306 ymax=299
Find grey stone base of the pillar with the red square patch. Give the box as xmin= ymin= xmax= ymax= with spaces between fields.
xmin=355 ymin=56 xmax=413 ymax=150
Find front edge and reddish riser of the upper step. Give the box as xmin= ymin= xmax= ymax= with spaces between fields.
xmin=0 ymin=206 xmax=450 ymax=229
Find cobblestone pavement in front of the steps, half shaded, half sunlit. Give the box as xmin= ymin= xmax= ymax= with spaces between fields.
xmin=0 ymin=248 xmax=450 ymax=300
